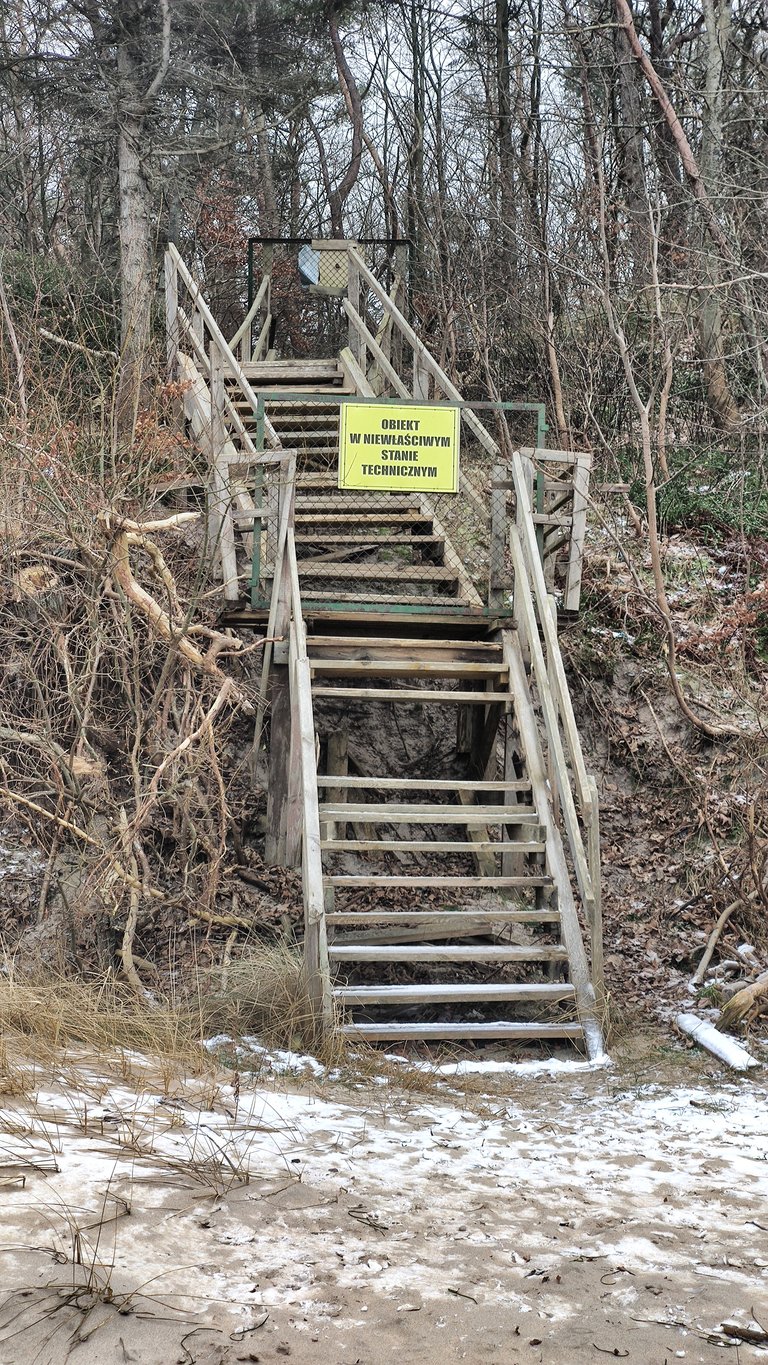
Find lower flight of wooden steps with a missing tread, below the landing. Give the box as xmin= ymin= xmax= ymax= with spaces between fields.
xmin=307 ymin=632 xmax=599 ymax=1050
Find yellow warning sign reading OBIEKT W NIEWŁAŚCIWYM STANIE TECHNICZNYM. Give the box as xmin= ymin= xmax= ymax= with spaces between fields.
xmin=338 ymin=403 xmax=460 ymax=493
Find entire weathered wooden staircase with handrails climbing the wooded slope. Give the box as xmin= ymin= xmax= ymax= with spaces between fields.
xmin=166 ymin=240 xmax=603 ymax=1058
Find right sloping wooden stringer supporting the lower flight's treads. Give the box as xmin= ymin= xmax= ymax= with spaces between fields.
xmin=502 ymin=631 xmax=604 ymax=1062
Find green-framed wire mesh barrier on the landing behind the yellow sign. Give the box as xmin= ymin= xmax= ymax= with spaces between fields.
xmin=250 ymin=393 xmax=545 ymax=612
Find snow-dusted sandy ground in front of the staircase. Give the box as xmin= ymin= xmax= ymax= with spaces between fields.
xmin=0 ymin=1037 xmax=768 ymax=1365
